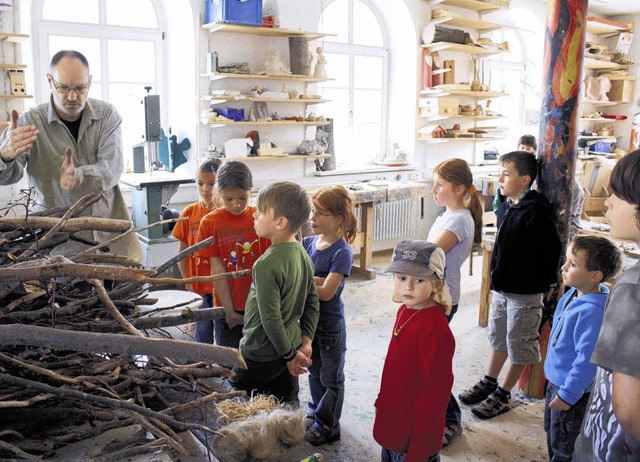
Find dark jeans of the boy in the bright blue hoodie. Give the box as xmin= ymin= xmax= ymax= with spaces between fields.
xmin=544 ymin=382 xmax=590 ymax=462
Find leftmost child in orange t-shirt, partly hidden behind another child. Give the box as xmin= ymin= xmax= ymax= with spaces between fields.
xmin=172 ymin=159 xmax=222 ymax=345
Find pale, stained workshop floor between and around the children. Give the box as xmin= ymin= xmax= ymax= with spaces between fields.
xmin=283 ymin=252 xmax=547 ymax=462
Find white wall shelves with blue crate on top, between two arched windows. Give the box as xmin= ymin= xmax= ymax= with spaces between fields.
xmin=199 ymin=23 xmax=329 ymax=164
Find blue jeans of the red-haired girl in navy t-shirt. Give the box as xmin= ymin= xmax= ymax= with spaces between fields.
xmin=309 ymin=320 xmax=347 ymax=435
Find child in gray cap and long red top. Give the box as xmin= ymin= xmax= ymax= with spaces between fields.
xmin=373 ymin=240 xmax=455 ymax=462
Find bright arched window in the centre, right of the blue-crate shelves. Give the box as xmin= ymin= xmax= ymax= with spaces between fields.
xmin=318 ymin=0 xmax=388 ymax=168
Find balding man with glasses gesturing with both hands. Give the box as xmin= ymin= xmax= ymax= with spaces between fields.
xmin=0 ymin=50 xmax=142 ymax=261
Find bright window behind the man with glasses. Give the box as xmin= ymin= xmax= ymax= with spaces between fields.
xmin=32 ymin=0 xmax=166 ymax=164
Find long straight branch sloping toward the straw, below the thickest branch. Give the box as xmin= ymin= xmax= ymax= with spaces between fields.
xmin=0 ymin=373 xmax=213 ymax=433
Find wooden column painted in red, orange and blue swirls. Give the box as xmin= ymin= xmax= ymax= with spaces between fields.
xmin=518 ymin=0 xmax=588 ymax=398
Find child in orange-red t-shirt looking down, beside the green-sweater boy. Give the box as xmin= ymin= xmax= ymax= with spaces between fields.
xmin=198 ymin=161 xmax=271 ymax=348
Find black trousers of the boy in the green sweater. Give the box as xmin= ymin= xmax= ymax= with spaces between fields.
xmin=229 ymin=358 xmax=300 ymax=409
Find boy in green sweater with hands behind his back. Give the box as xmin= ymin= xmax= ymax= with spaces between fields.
xmin=230 ymin=182 xmax=320 ymax=407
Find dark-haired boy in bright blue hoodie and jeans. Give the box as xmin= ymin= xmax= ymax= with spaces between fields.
xmin=544 ymin=236 xmax=622 ymax=462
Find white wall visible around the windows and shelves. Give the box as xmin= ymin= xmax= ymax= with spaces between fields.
xmin=6 ymin=0 xmax=624 ymax=211
